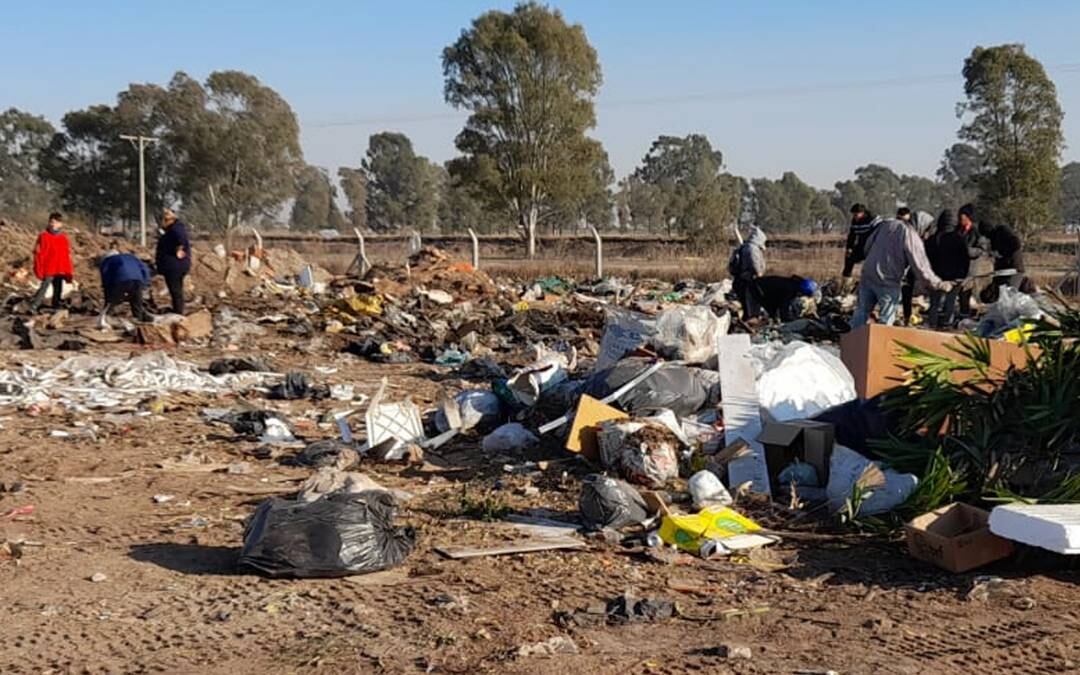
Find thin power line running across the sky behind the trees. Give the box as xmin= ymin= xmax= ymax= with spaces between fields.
xmin=303 ymin=63 xmax=1080 ymax=130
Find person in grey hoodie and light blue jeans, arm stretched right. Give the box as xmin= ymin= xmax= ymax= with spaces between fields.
xmin=851 ymin=218 xmax=953 ymax=328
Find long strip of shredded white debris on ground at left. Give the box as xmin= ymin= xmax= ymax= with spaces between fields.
xmin=0 ymin=351 xmax=280 ymax=413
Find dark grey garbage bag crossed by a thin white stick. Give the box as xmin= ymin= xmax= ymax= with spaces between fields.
xmin=584 ymin=357 xmax=720 ymax=417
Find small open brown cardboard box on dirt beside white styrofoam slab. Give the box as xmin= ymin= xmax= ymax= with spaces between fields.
xmin=904 ymin=503 xmax=1013 ymax=572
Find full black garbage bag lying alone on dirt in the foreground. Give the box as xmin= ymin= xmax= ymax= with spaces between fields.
xmin=240 ymin=490 xmax=416 ymax=578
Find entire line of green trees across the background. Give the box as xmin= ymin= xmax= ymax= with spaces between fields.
xmin=0 ymin=2 xmax=1080 ymax=248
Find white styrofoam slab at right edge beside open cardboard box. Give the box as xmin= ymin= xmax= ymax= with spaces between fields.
xmin=990 ymin=503 xmax=1080 ymax=555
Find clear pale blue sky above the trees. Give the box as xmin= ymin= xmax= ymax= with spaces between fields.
xmin=0 ymin=0 xmax=1080 ymax=187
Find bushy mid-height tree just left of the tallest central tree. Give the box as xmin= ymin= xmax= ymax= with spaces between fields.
xmin=363 ymin=132 xmax=438 ymax=232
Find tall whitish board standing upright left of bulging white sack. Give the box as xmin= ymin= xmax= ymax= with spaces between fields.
xmin=716 ymin=334 xmax=770 ymax=495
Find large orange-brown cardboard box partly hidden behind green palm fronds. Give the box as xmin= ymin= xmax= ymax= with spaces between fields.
xmin=840 ymin=324 xmax=1034 ymax=399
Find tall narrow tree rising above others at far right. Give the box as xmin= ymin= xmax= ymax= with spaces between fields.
xmin=958 ymin=44 xmax=1065 ymax=235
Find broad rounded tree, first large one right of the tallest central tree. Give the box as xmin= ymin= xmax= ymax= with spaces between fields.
xmin=634 ymin=134 xmax=746 ymax=238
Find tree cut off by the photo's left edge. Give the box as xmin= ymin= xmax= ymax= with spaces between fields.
xmin=0 ymin=108 xmax=56 ymax=218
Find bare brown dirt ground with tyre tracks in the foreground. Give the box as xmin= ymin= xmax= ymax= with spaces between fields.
xmin=0 ymin=338 xmax=1080 ymax=675
